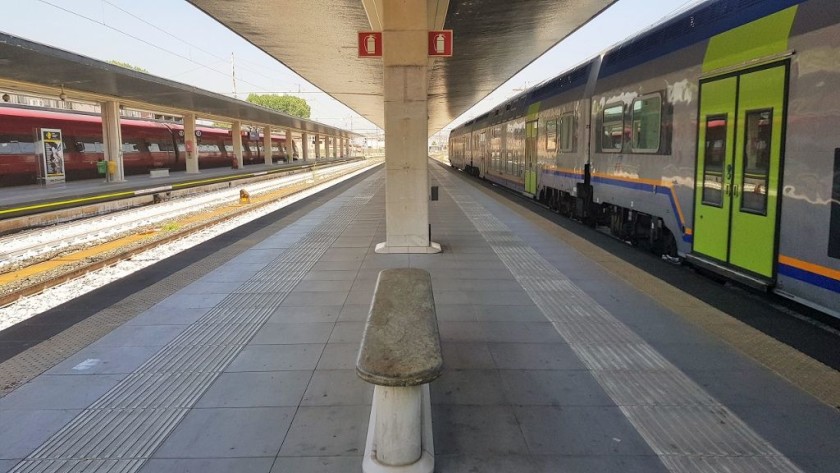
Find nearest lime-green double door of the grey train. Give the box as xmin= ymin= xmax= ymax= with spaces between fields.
xmin=693 ymin=65 xmax=787 ymax=279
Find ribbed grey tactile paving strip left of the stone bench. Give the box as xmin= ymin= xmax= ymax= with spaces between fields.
xmin=11 ymin=172 xmax=384 ymax=473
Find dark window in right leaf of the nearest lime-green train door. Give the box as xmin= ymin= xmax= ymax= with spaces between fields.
xmin=740 ymin=109 xmax=773 ymax=215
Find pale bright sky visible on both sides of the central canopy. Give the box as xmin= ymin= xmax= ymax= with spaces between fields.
xmin=0 ymin=0 xmax=703 ymax=135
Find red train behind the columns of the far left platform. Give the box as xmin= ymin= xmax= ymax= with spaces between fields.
xmin=0 ymin=106 xmax=298 ymax=186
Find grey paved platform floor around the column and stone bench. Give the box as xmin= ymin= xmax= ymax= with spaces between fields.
xmin=0 ymin=160 xmax=840 ymax=473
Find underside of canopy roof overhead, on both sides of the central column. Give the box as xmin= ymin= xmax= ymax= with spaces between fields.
xmin=188 ymin=0 xmax=615 ymax=134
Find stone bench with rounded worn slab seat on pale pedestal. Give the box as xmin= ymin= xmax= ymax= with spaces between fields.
xmin=356 ymin=268 xmax=443 ymax=473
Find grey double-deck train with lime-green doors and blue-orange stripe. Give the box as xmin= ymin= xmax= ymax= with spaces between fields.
xmin=449 ymin=0 xmax=840 ymax=317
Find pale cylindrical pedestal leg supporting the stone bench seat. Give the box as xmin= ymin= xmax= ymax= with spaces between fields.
xmin=362 ymin=384 xmax=434 ymax=473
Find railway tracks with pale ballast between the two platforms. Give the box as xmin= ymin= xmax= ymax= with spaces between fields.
xmin=0 ymin=160 xmax=376 ymax=314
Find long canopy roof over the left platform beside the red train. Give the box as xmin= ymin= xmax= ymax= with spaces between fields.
xmin=0 ymin=33 xmax=352 ymax=137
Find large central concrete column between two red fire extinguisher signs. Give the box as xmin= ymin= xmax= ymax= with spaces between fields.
xmin=376 ymin=0 xmax=440 ymax=253
